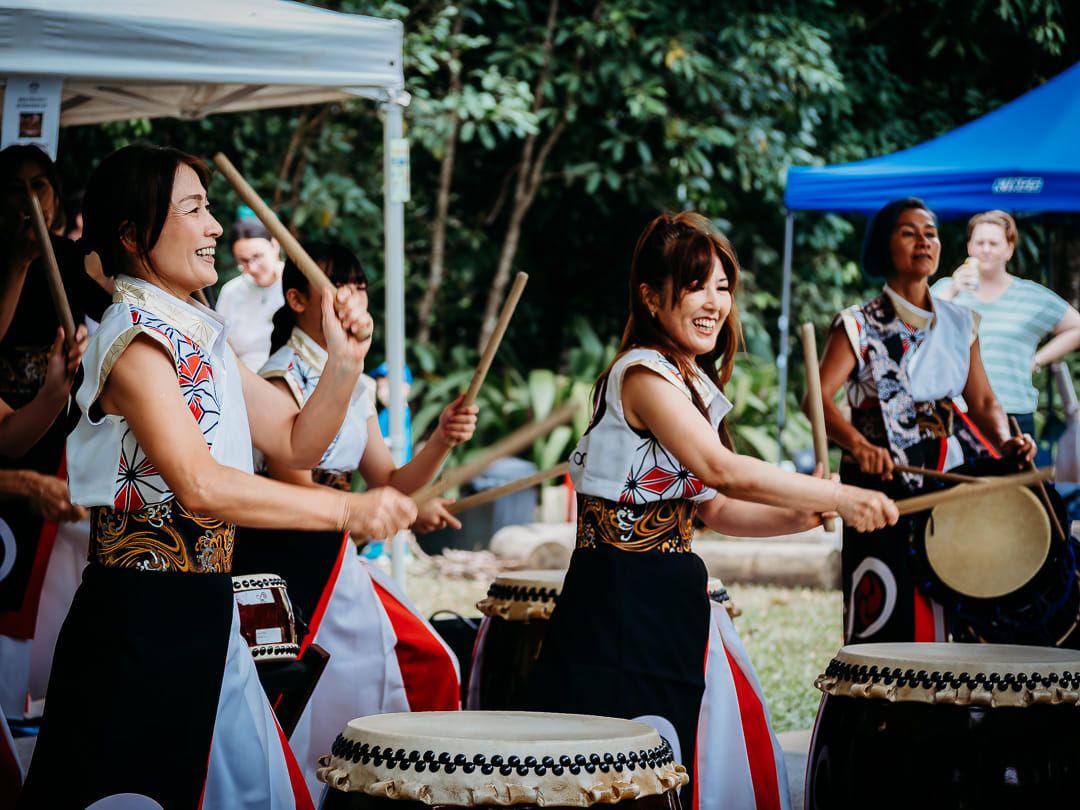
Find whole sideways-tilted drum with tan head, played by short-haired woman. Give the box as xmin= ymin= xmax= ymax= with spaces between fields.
xmin=909 ymin=479 xmax=1080 ymax=649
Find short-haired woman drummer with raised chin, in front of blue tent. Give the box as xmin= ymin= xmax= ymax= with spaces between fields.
xmin=804 ymin=198 xmax=1035 ymax=643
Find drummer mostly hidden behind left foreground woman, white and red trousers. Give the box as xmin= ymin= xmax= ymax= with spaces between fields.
xmin=234 ymin=244 xmax=478 ymax=801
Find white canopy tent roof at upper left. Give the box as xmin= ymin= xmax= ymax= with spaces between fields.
xmin=0 ymin=0 xmax=407 ymax=125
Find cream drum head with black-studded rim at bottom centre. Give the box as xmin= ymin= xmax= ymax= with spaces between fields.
xmin=318 ymin=712 xmax=688 ymax=807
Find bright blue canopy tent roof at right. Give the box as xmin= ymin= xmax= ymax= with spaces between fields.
xmin=784 ymin=63 xmax=1080 ymax=216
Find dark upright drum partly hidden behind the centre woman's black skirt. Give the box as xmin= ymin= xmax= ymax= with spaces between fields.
xmin=467 ymin=570 xmax=566 ymax=710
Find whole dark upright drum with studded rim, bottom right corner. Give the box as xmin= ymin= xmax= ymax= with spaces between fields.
xmin=806 ymin=644 xmax=1080 ymax=810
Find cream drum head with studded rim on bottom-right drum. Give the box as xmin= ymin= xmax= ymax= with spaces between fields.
xmin=814 ymin=643 xmax=1080 ymax=711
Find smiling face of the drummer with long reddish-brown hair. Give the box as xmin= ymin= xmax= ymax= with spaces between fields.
xmin=651 ymin=258 xmax=731 ymax=357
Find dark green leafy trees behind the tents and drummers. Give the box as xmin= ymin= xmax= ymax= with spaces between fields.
xmin=62 ymin=0 xmax=1080 ymax=455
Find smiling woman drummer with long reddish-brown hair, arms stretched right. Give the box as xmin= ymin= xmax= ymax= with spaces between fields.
xmin=529 ymin=213 xmax=897 ymax=807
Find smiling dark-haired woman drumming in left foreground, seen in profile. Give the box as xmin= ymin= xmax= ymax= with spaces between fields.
xmin=21 ymin=146 xmax=416 ymax=808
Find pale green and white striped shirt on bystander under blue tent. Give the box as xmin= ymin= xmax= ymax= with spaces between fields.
xmin=930 ymin=276 xmax=1069 ymax=414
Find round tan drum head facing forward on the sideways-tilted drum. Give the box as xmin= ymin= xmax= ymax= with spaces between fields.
xmin=926 ymin=487 xmax=1050 ymax=599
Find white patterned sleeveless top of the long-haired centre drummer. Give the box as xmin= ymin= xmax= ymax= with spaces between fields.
xmin=570 ymin=349 xmax=731 ymax=504
